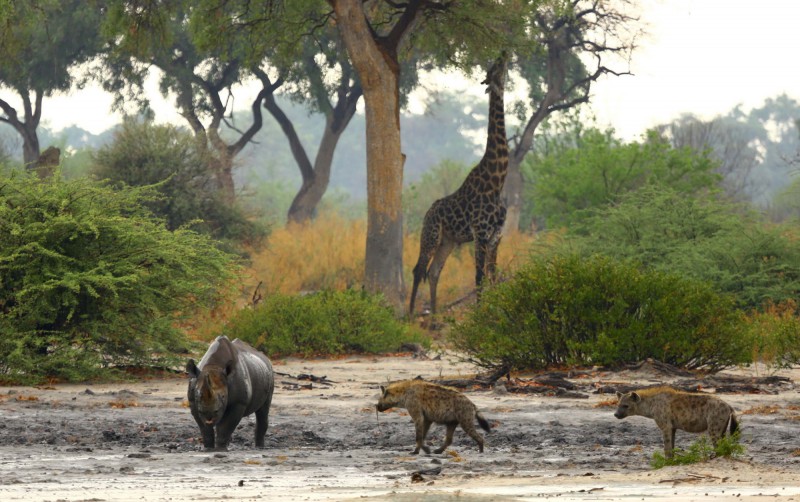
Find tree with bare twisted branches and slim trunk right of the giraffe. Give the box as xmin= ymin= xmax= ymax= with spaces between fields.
xmin=504 ymin=0 xmax=638 ymax=230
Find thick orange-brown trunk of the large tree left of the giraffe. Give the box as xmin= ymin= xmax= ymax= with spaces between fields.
xmin=333 ymin=0 xmax=405 ymax=313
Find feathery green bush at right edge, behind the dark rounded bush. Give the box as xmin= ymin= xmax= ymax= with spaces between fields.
xmin=574 ymin=186 xmax=800 ymax=309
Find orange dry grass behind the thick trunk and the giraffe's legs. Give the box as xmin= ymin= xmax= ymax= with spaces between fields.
xmin=242 ymin=215 xmax=535 ymax=314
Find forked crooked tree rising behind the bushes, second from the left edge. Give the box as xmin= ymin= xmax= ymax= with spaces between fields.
xmin=103 ymin=2 xmax=272 ymax=204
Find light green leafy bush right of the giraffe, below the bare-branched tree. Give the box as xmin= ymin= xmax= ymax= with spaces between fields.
xmin=521 ymin=126 xmax=720 ymax=228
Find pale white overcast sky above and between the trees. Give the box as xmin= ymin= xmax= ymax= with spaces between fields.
xmin=21 ymin=0 xmax=800 ymax=139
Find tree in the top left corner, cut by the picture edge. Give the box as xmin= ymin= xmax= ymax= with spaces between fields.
xmin=0 ymin=0 xmax=102 ymax=167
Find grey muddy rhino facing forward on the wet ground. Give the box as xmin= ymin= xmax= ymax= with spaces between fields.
xmin=186 ymin=336 xmax=275 ymax=450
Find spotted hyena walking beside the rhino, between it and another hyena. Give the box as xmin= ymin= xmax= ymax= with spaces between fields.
xmin=375 ymin=380 xmax=491 ymax=455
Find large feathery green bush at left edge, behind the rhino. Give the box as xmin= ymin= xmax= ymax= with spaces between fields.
xmin=0 ymin=171 xmax=235 ymax=382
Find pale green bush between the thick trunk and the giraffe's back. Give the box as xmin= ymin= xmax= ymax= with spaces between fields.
xmin=403 ymin=160 xmax=470 ymax=233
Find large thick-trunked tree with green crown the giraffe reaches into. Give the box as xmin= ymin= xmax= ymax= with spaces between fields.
xmin=330 ymin=0 xmax=525 ymax=311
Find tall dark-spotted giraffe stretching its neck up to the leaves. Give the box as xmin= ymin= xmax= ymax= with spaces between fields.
xmin=408 ymin=53 xmax=508 ymax=317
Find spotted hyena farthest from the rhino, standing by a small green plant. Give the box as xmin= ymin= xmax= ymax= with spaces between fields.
xmin=614 ymin=387 xmax=739 ymax=458
